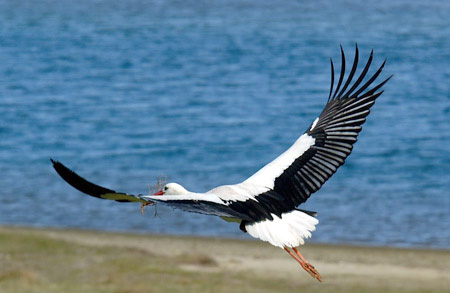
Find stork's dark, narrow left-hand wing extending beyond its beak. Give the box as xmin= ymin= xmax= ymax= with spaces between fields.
xmin=50 ymin=159 xmax=148 ymax=203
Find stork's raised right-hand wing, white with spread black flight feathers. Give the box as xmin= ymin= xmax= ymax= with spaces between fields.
xmin=244 ymin=46 xmax=392 ymax=209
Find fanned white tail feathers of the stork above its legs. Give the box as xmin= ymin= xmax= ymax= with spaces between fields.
xmin=245 ymin=210 xmax=319 ymax=248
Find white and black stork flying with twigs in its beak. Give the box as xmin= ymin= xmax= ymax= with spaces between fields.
xmin=51 ymin=46 xmax=392 ymax=281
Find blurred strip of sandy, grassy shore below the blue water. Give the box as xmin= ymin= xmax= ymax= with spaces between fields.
xmin=0 ymin=227 xmax=450 ymax=292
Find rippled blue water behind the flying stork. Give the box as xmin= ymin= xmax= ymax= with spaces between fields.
xmin=0 ymin=0 xmax=450 ymax=249
